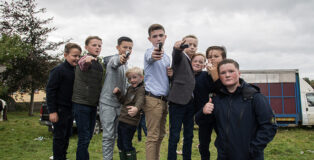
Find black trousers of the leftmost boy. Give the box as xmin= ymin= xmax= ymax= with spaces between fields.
xmin=52 ymin=108 xmax=73 ymax=160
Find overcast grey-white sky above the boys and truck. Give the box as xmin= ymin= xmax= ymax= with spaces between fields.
xmin=38 ymin=0 xmax=314 ymax=79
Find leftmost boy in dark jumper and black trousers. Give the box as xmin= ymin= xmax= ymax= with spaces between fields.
xmin=46 ymin=43 xmax=82 ymax=160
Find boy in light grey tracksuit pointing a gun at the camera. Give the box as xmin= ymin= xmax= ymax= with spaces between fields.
xmin=99 ymin=37 xmax=133 ymax=160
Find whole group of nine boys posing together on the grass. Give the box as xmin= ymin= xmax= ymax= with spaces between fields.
xmin=46 ymin=24 xmax=276 ymax=160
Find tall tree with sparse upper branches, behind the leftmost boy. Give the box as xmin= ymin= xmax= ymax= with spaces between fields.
xmin=0 ymin=0 xmax=65 ymax=116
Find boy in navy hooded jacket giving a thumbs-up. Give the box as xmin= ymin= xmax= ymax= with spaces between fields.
xmin=203 ymin=59 xmax=277 ymax=160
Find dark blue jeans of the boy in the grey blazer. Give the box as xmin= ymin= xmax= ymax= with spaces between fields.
xmin=168 ymin=100 xmax=194 ymax=160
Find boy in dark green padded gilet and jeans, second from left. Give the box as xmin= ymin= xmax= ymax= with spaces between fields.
xmin=72 ymin=36 xmax=103 ymax=160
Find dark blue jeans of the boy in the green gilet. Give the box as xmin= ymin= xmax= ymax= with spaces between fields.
xmin=73 ymin=102 xmax=97 ymax=160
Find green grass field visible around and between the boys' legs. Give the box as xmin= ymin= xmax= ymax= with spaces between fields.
xmin=0 ymin=112 xmax=314 ymax=160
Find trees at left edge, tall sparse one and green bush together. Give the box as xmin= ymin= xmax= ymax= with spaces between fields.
xmin=0 ymin=0 xmax=65 ymax=115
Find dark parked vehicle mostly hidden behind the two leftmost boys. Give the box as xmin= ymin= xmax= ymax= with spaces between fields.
xmin=39 ymin=102 xmax=102 ymax=134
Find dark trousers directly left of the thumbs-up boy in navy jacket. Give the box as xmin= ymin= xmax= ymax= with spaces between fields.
xmin=198 ymin=123 xmax=214 ymax=160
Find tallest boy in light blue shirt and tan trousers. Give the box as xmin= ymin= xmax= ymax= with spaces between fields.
xmin=143 ymin=24 xmax=170 ymax=160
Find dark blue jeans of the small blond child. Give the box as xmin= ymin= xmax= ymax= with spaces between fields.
xmin=117 ymin=121 xmax=136 ymax=152
